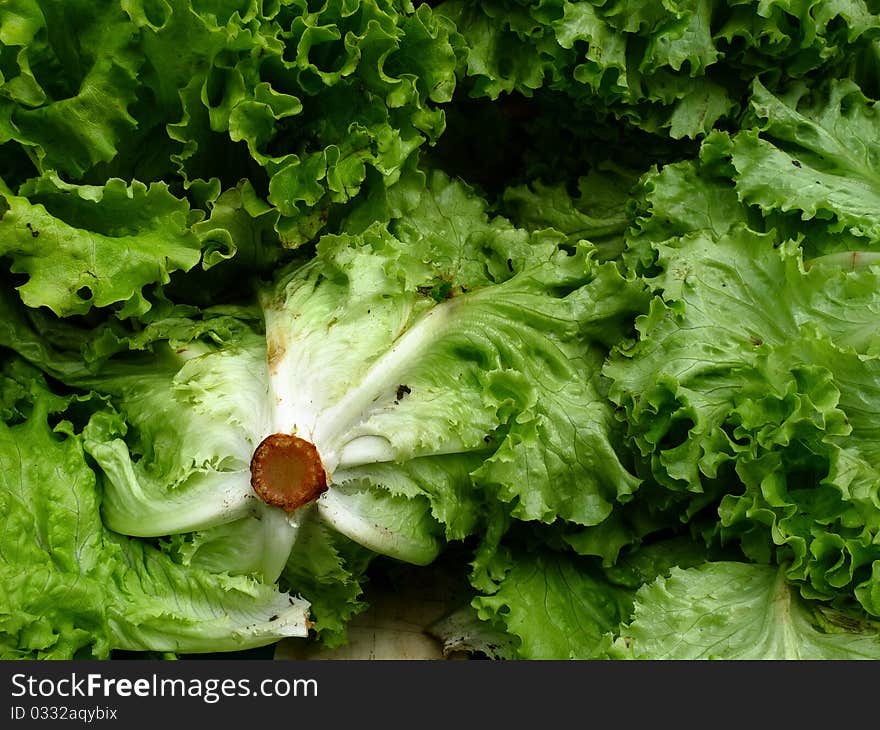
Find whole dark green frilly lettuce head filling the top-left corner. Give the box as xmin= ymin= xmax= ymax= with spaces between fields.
xmin=0 ymin=0 xmax=459 ymax=252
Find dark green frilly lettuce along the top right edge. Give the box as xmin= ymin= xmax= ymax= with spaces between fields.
xmin=439 ymin=0 xmax=877 ymax=139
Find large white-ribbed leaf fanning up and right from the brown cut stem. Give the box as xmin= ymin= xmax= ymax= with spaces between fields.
xmin=263 ymin=174 xmax=638 ymax=552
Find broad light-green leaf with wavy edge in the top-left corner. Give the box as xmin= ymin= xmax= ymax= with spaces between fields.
xmin=0 ymin=0 xmax=141 ymax=179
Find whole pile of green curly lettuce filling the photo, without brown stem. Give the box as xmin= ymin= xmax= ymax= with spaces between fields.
xmin=0 ymin=0 xmax=880 ymax=659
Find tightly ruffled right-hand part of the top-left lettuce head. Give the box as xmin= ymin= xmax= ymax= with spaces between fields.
xmin=162 ymin=0 xmax=456 ymax=247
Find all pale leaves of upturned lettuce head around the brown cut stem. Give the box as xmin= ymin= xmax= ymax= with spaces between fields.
xmin=10 ymin=166 xmax=645 ymax=580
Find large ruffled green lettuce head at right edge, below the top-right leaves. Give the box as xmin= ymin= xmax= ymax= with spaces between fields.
xmin=604 ymin=227 xmax=880 ymax=615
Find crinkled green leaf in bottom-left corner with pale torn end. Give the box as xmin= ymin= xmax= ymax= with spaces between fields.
xmin=0 ymin=360 xmax=308 ymax=659
